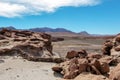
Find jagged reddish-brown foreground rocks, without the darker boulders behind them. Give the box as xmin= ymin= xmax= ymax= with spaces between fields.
xmin=52 ymin=54 xmax=110 ymax=79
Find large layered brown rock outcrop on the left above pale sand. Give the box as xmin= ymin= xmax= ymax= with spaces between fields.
xmin=0 ymin=29 xmax=62 ymax=62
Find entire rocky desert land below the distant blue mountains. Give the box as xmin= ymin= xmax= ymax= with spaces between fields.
xmin=0 ymin=28 xmax=120 ymax=80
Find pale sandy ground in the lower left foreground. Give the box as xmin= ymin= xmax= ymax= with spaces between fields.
xmin=0 ymin=57 xmax=60 ymax=80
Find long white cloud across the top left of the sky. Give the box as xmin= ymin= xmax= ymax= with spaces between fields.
xmin=0 ymin=0 xmax=100 ymax=17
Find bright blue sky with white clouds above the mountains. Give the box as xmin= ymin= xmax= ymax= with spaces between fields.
xmin=0 ymin=0 xmax=120 ymax=34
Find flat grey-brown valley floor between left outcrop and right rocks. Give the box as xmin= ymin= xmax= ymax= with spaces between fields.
xmin=52 ymin=39 xmax=104 ymax=57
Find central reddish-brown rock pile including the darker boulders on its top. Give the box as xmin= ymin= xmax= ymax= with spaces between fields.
xmin=52 ymin=50 xmax=110 ymax=79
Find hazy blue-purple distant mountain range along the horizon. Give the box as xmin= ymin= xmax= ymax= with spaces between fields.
xmin=0 ymin=26 xmax=110 ymax=36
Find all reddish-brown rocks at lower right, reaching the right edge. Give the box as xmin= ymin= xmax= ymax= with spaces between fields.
xmin=52 ymin=34 xmax=120 ymax=80
